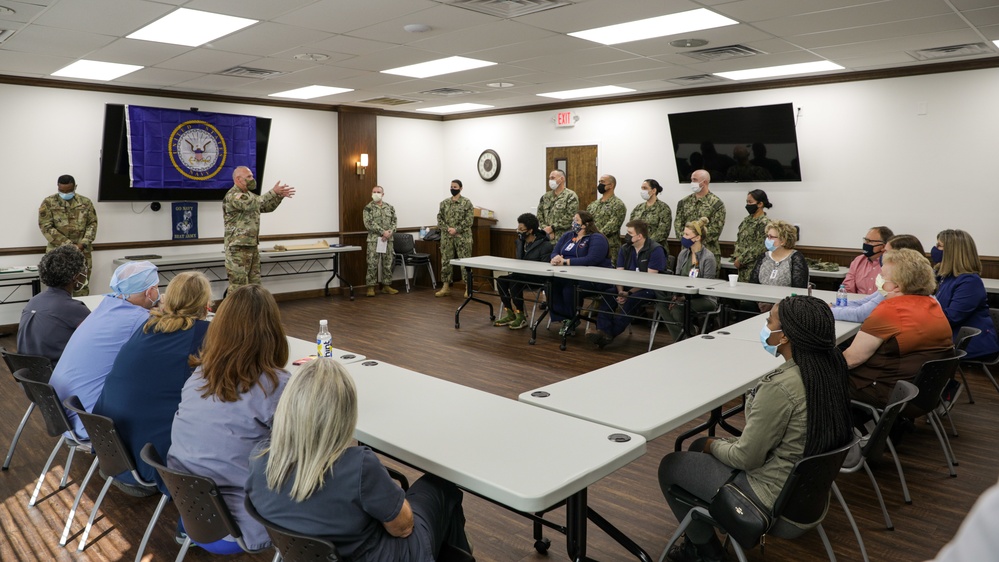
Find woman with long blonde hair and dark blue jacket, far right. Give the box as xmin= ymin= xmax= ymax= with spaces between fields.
xmin=937 ymin=230 xmax=999 ymax=359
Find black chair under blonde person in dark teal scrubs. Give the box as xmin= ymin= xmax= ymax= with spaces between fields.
xmin=59 ymin=396 xmax=158 ymax=560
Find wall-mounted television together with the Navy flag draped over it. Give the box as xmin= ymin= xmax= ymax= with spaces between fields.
xmin=97 ymin=104 xmax=271 ymax=201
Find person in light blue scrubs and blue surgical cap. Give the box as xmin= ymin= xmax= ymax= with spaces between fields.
xmin=49 ymin=261 xmax=160 ymax=438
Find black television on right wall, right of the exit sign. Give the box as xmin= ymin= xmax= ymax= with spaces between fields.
xmin=669 ymin=103 xmax=801 ymax=183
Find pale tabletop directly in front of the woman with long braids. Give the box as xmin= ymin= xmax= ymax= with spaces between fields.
xmin=518 ymin=327 xmax=784 ymax=450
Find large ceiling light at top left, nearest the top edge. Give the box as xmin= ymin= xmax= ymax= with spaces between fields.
xmin=127 ymin=8 xmax=258 ymax=47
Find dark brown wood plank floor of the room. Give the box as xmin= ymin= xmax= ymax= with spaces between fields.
xmin=0 ymin=287 xmax=999 ymax=562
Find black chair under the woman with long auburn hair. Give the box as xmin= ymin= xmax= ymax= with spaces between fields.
xmin=139 ymin=443 xmax=262 ymax=562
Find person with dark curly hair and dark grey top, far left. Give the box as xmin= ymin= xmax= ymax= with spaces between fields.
xmin=17 ymin=244 xmax=90 ymax=365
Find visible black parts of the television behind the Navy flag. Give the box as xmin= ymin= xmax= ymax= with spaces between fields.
xmin=97 ymin=104 xmax=271 ymax=201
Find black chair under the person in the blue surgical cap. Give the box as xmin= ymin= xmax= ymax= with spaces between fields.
xmin=14 ymin=369 xmax=93 ymax=507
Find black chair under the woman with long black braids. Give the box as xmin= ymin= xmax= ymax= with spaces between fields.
xmin=659 ymin=441 xmax=867 ymax=562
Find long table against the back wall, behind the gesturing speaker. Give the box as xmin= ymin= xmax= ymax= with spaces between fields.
xmin=114 ymin=246 xmax=361 ymax=300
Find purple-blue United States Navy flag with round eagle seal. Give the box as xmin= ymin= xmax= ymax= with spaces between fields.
xmin=126 ymin=105 xmax=257 ymax=189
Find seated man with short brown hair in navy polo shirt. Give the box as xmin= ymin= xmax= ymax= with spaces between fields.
xmin=586 ymin=220 xmax=666 ymax=348
